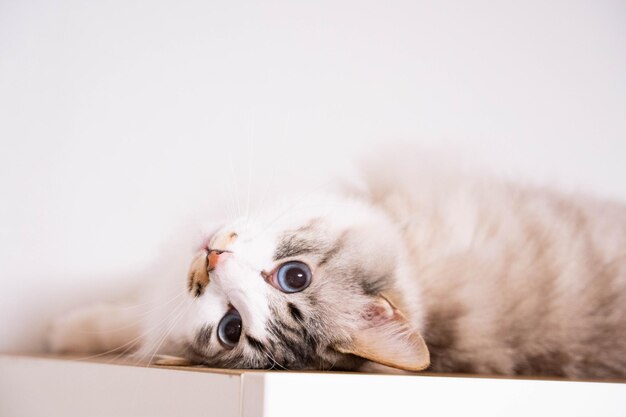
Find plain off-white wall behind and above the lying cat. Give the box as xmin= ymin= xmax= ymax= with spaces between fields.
xmin=0 ymin=0 xmax=626 ymax=351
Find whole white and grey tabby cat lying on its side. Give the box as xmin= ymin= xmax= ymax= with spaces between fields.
xmin=49 ymin=155 xmax=626 ymax=378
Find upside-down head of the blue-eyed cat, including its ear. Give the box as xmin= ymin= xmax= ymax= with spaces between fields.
xmin=176 ymin=193 xmax=428 ymax=370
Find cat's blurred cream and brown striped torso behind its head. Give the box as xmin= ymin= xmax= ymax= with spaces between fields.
xmin=358 ymin=162 xmax=626 ymax=377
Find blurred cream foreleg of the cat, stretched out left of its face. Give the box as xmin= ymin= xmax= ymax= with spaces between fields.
xmin=48 ymin=303 xmax=143 ymax=354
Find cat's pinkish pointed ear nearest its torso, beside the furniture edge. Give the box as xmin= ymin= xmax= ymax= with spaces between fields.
xmin=336 ymin=296 xmax=430 ymax=371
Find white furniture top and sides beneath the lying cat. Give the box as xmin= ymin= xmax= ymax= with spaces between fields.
xmin=0 ymin=355 xmax=626 ymax=417
